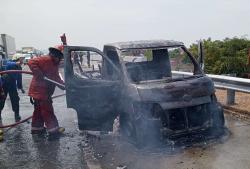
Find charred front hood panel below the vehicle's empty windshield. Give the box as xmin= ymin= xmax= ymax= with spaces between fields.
xmin=136 ymin=76 xmax=215 ymax=106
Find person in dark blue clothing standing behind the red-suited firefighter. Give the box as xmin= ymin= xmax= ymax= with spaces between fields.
xmin=0 ymin=54 xmax=25 ymax=122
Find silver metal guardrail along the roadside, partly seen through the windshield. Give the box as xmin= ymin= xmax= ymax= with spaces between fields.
xmin=172 ymin=71 xmax=250 ymax=104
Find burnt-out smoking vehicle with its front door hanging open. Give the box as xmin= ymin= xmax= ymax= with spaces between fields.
xmin=64 ymin=40 xmax=224 ymax=143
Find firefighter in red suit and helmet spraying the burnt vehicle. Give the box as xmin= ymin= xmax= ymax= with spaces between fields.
xmin=28 ymin=46 xmax=65 ymax=136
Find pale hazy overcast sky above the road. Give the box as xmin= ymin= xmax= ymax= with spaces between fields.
xmin=0 ymin=0 xmax=250 ymax=49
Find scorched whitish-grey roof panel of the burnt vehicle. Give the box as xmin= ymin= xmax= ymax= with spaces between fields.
xmin=105 ymin=40 xmax=184 ymax=50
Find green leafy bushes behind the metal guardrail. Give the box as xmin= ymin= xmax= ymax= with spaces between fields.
xmin=189 ymin=37 xmax=250 ymax=76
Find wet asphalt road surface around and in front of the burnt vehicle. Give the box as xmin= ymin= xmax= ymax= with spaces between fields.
xmin=0 ymin=69 xmax=250 ymax=169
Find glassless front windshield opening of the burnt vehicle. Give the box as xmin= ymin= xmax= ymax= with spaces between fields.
xmin=122 ymin=47 xmax=194 ymax=83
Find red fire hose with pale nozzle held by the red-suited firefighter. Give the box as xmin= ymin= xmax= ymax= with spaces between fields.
xmin=0 ymin=70 xmax=65 ymax=129
